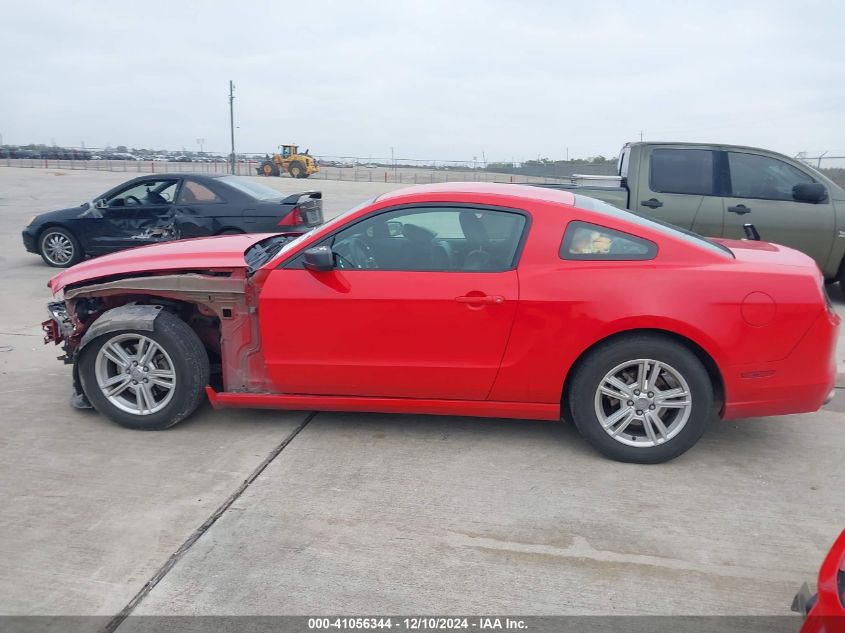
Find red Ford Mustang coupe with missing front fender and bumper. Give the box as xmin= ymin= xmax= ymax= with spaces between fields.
xmin=44 ymin=183 xmax=839 ymax=463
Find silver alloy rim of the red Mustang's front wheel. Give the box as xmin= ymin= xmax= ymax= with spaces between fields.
xmin=94 ymin=333 xmax=176 ymax=415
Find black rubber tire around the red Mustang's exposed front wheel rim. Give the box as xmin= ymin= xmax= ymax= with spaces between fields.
xmin=78 ymin=310 xmax=209 ymax=431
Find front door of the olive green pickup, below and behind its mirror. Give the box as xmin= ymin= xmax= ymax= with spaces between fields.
xmin=723 ymin=150 xmax=836 ymax=268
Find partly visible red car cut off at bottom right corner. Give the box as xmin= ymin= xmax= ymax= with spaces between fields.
xmin=792 ymin=530 xmax=845 ymax=633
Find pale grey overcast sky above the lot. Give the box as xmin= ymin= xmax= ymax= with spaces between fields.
xmin=0 ymin=0 xmax=845 ymax=161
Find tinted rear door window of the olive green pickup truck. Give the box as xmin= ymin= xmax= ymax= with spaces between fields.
xmin=649 ymin=148 xmax=714 ymax=196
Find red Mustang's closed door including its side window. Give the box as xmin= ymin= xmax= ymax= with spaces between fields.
xmin=259 ymin=207 xmax=528 ymax=400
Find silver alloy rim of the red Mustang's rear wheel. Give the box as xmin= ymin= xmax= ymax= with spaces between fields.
xmin=595 ymin=358 xmax=692 ymax=448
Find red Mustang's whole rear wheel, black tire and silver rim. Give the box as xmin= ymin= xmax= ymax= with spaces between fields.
xmin=568 ymin=335 xmax=713 ymax=464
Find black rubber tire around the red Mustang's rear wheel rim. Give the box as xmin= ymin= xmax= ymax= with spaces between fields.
xmin=565 ymin=334 xmax=713 ymax=464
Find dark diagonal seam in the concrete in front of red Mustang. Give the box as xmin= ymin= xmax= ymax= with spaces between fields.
xmin=99 ymin=411 xmax=318 ymax=633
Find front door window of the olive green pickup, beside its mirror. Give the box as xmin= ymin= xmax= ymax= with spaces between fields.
xmin=728 ymin=152 xmax=814 ymax=200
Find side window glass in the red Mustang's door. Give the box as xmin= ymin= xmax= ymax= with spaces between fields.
xmin=331 ymin=207 xmax=527 ymax=272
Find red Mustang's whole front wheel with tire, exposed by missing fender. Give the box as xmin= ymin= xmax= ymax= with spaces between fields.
xmin=78 ymin=311 xmax=209 ymax=431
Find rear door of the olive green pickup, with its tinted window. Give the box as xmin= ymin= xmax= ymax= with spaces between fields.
xmin=630 ymin=146 xmax=722 ymax=237
